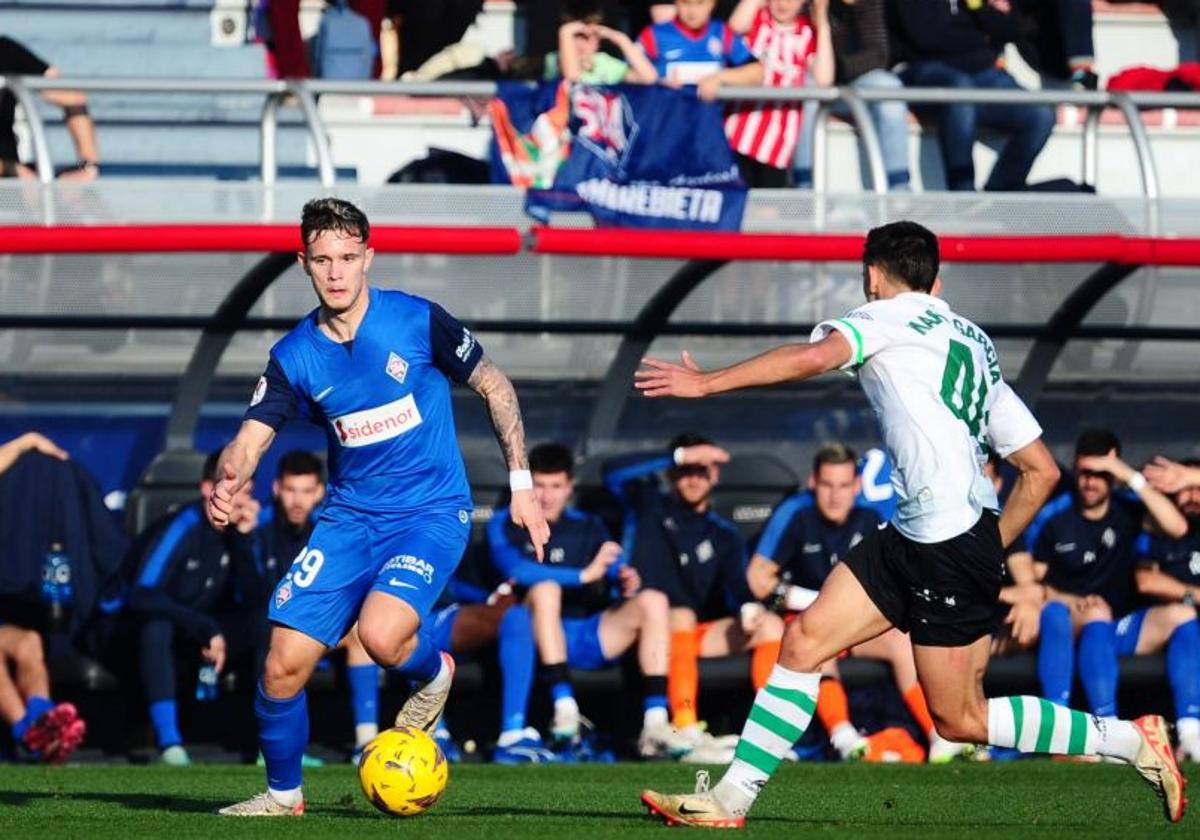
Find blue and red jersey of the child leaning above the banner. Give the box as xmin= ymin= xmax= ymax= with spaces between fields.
xmin=637 ymin=20 xmax=756 ymax=84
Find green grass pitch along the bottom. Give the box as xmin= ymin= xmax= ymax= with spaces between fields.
xmin=0 ymin=761 xmax=1200 ymax=840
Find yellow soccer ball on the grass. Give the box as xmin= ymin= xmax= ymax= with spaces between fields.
xmin=359 ymin=727 xmax=450 ymax=817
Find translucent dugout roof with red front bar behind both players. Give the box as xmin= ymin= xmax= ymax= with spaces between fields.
xmin=0 ymin=179 xmax=1200 ymax=453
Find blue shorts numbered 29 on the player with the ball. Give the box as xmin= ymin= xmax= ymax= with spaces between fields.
xmin=268 ymin=508 xmax=470 ymax=647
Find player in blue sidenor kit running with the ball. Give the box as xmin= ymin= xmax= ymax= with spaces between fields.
xmin=206 ymin=198 xmax=550 ymax=816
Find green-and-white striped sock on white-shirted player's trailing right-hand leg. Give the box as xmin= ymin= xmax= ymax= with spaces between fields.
xmin=988 ymin=697 xmax=1141 ymax=762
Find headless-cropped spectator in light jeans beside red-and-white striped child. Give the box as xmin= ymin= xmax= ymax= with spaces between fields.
xmin=794 ymin=0 xmax=910 ymax=191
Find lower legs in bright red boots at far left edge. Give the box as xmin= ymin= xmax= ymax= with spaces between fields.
xmin=0 ymin=623 xmax=88 ymax=764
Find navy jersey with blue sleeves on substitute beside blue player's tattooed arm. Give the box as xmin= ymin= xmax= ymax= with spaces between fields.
xmin=487 ymin=508 xmax=612 ymax=618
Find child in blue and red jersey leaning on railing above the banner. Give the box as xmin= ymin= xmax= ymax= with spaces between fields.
xmin=637 ymin=0 xmax=762 ymax=100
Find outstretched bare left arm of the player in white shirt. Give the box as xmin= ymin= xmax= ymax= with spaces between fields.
xmin=634 ymin=331 xmax=852 ymax=397
